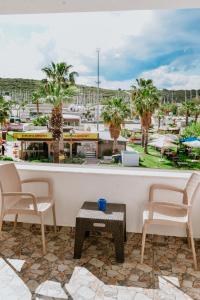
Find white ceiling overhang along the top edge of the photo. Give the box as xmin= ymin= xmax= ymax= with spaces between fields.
xmin=0 ymin=0 xmax=200 ymax=14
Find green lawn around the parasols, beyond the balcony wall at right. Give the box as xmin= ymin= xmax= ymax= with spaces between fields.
xmin=129 ymin=144 xmax=200 ymax=170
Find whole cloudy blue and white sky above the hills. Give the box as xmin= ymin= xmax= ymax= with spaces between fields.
xmin=0 ymin=10 xmax=200 ymax=89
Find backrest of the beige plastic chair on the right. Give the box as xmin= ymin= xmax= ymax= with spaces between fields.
xmin=185 ymin=172 xmax=200 ymax=205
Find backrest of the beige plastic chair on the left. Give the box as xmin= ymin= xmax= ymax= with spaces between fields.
xmin=0 ymin=163 xmax=21 ymax=210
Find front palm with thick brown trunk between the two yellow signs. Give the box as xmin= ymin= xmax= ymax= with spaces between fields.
xmin=42 ymin=81 xmax=75 ymax=163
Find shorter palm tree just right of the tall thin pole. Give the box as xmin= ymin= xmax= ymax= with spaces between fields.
xmin=101 ymin=98 xmax=130 ymax=153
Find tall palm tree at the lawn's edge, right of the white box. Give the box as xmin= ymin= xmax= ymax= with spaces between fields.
xmin=132 ymin=78 xmax=160 ymax=153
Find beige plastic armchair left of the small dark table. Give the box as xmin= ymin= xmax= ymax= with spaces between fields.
xmin=0 ymin=163 xmax=56 ymax=254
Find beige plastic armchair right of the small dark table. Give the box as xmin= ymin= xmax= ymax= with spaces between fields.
xmin=141 ymin=173 xmax=200 ymax=269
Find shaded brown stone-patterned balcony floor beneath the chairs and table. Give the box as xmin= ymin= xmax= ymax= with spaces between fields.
xmin=0 ymin=223 xmax=200 ymax=300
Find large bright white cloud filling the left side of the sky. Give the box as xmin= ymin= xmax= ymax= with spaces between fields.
xmin=0 ymin=11 xmax=152 ymax=80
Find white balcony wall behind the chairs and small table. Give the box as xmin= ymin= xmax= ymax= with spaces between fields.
xmin=3 ymin=164 xmax=200 ymax=237
